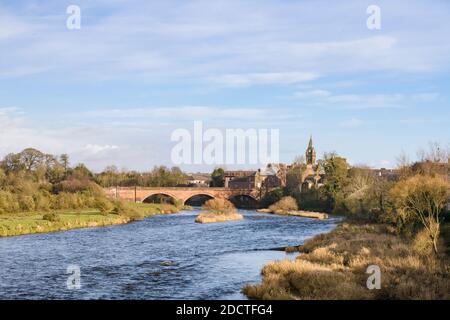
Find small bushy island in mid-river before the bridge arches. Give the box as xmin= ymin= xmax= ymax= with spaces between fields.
xmin=195 ymin=199 xmax=243 ymax=223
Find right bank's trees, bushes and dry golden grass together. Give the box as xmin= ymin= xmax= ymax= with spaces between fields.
xmin=243 ymin=145 xmax=450 ymax=299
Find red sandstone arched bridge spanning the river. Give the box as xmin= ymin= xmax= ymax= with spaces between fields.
xmin=104 ymin=187 xmax=260 ymax=204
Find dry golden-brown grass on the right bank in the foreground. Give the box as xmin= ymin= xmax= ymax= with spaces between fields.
xmin=243 ymin=223 xmax=450 ymax=299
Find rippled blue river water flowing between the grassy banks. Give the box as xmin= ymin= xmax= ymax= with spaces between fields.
xmin=0 ymin=210 xmax=338 ymax=299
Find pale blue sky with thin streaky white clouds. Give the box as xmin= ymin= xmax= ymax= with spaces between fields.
xmin=0 ymin=0 xmax=450 ymax=171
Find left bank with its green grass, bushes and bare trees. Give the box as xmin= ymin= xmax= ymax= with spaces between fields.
xmin=0 ymin=148 xmax=181 ymax=236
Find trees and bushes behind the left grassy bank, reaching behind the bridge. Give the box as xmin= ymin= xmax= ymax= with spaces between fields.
xmin=0 ymin=148 xmax=187 ymax=214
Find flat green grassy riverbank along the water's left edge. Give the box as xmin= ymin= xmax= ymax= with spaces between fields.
xmin=0 ymin=203 xmax=183 ymax=237
